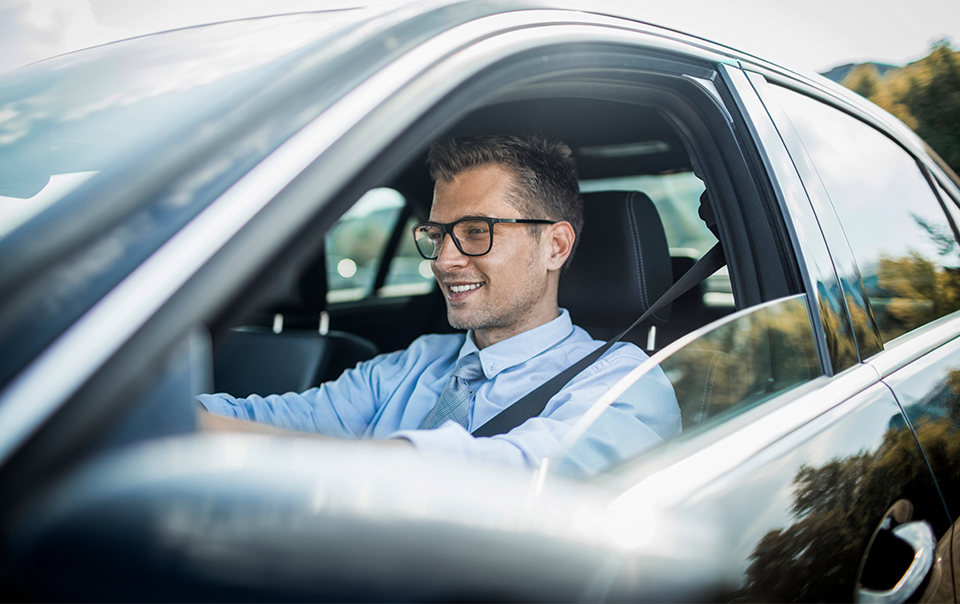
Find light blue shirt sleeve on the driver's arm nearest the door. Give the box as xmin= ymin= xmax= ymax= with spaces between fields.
xmin=393 ymin=346 xmax=680 ymax=476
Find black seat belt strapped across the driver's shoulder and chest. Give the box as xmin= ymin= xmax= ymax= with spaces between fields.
xmin=473 ymin=243 xmax=726 ymax=436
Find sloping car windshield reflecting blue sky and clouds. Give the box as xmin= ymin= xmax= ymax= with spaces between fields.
xmin=0 ymin=11 xmax=356 ymax=238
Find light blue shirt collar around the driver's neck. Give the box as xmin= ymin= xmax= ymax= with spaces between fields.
xmin=457 ymin=308 xmax=573 ymax=380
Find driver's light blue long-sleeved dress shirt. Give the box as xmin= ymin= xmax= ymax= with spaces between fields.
xmin=198 ymin=309 xmax=680 ymax=475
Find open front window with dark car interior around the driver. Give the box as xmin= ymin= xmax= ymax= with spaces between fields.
xmin=215 ymin=44 xmax=800 ymax=394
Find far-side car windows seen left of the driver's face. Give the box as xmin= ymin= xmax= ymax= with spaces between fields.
xmin=325 ymin=187 xmax=433 ymax=302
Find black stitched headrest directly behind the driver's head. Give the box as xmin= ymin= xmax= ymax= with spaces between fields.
xmin=559 ymin=191 xmax=673 ymax=337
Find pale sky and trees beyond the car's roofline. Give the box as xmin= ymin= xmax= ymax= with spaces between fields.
xmin=0 ymin=0 xmax=960 ymax=171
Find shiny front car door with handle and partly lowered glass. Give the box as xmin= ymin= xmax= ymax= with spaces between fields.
xmin=556 ymin=295 xmax=953 ymax=602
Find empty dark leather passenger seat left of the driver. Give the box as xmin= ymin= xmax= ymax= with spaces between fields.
xmin=214 ymin=245 xmax=378 ymax=397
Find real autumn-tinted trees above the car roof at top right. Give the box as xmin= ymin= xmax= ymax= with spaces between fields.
xmin=841 ymin=40 xmax=960 ymax=172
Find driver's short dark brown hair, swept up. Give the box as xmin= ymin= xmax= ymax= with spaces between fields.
xmin=427 ymin=134 xmax=583 ymax=268
